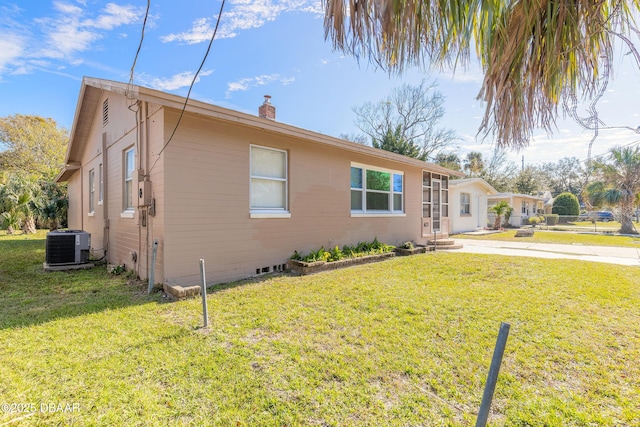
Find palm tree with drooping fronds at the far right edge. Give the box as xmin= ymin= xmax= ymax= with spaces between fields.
xmin=586 ymin=147 xmax=640 ymax=234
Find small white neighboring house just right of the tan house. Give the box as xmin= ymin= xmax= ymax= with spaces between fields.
xmin=449 ymin=178 xmax=498 ymax=234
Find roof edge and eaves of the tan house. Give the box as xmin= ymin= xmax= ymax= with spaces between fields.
xmin=56 ymin=77 xmax=463 ymax=181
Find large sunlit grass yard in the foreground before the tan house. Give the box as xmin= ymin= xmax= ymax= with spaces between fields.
xmin=0 ymin=233 xmax=640 ymax=427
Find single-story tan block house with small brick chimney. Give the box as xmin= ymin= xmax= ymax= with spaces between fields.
xmin=57 ymin=78 xmax=460 ymax=285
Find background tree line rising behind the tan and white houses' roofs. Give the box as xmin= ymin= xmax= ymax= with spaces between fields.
xmin=348 ymin=80 xmax=640 ymax=233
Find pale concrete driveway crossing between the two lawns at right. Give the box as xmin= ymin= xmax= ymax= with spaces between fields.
xmin=453 ymin=237 xmax=640 ymax=266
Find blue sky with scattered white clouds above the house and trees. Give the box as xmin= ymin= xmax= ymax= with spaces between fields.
xmin=0 ymin=0 xmax=640 ymax=164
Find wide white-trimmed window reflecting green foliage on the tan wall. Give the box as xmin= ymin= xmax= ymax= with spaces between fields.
xmin=351 ymin=165 xmax=404 ymax=214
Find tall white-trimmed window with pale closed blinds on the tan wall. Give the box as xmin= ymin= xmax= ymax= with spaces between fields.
xmin=251 ymin=145 xmax=288 ymax=214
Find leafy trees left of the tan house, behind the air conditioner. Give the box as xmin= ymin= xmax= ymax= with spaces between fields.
xmin=0 ymin=114 xmax=69 ymax=234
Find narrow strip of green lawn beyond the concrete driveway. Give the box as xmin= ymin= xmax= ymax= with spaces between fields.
xmin=452 ymin=229 xmax=640 ymax=248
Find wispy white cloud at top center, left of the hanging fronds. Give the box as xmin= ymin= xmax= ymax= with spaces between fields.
xmin=160 ymin=0 xmax=323 ymax=44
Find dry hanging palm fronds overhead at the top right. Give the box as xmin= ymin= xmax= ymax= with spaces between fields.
xmin=324 ymin=0 xmax=640 ymax=148
